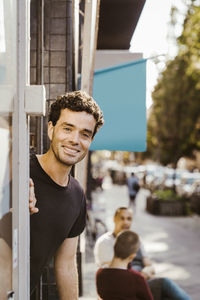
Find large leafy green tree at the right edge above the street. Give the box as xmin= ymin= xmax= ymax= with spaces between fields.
xmin=147 ymin=4 xmax=200 ymax=166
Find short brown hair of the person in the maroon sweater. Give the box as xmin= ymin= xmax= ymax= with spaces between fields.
xmin=114 ymin=230 xmax=140 ymax=259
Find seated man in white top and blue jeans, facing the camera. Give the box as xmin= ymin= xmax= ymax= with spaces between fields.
xmin=94 ymin=207 xmax=191 ymax=300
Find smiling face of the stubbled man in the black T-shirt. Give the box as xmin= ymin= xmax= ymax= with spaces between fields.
xmin=48 ymin=108 xmax=96 ymax=166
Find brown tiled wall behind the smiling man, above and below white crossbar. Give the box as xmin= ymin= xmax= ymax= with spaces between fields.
xmin=30 ymin=0 xmax=73 ymax=152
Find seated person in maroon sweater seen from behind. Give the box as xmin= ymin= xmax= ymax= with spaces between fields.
xmin=96 ymin=230 xmax=153 ymax=300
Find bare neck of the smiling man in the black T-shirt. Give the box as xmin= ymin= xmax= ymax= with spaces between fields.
xmin=37 ymin=150 xmax=71 ymax=186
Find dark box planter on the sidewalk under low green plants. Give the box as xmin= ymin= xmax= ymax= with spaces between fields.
xmin=146 ymin=196 xmax=186 ymax=216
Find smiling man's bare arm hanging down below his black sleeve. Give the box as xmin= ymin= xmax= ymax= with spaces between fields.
xmin=54 ymin=237 xmax=78 ymax=300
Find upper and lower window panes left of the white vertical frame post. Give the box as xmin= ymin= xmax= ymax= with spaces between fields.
xmin=0 ymin=0 xmax=16 ymax=300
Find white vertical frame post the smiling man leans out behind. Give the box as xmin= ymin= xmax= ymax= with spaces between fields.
xmin=12 ymin=0 xmax=30 ymax=300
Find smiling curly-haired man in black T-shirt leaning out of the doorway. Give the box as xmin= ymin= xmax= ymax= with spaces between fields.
xmin=29 ymin=91 xmax=104 ymax=300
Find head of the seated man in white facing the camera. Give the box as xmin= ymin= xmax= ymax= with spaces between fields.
xmin=114 ymin=209 xmax=133 ymax=234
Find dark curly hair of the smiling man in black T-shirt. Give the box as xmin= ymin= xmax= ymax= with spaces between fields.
xmin=48 ymin=91 xmax=104 ymax=136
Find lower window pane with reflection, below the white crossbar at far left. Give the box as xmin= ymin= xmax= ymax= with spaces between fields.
xmin=0 ymin=116 xmax=12 ymax=300
